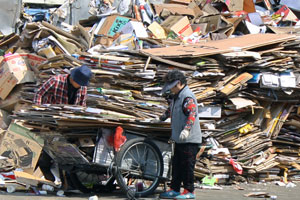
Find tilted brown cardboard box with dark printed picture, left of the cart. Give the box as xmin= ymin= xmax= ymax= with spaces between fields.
xmin=0 ymin=123 xmax=44 ymax=171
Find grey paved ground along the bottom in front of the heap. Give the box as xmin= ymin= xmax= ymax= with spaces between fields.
xmin=0 ymin=182 xmax=300 ymax=200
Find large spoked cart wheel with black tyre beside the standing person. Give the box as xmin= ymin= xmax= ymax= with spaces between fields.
xmin=115 ymin=138 xmax=163 ymax=197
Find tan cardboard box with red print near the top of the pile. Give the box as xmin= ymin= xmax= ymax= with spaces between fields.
xmin=161 ymin=16 xmax=193 ymax=36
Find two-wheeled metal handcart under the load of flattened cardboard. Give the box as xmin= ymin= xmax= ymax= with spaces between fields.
xmin=44 ymin=126 xmax=171 ymax=199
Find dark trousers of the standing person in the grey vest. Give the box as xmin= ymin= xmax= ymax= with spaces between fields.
xmin=171 ymin=143 xmax=199 ymax=192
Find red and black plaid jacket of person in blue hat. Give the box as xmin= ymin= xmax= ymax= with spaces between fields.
xmin=33 ymin=74 xmax=87 ymax=106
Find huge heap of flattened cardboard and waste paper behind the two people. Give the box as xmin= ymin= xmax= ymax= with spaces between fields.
xmin=0 ymin=0 xmax=300 ymax=195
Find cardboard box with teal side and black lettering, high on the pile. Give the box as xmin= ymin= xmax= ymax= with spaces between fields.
xmin=96 ymin=15 xmax=131 ymax=37
